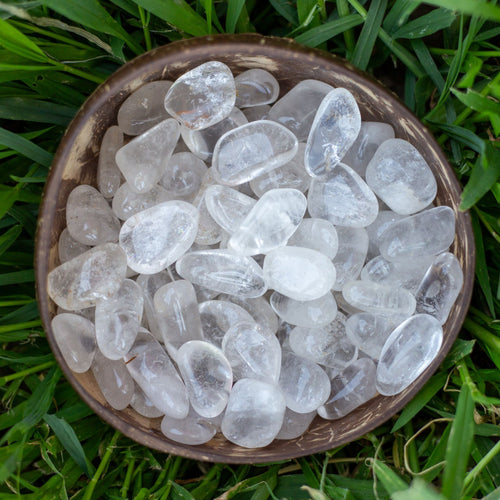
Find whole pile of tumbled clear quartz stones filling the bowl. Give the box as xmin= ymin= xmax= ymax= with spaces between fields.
xmin=48 ymin=62 xmax=463 ymax=448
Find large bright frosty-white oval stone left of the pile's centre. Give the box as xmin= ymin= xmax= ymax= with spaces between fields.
xmin=120 ymin=200 xmax=198 ymax=274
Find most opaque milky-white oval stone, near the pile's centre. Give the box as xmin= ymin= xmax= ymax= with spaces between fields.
xmin=264 ymin=247 xmax=336 ymax=301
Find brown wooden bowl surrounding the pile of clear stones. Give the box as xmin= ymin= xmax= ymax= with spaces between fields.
xmin=35 ymin=35 xmax=474 ymax=463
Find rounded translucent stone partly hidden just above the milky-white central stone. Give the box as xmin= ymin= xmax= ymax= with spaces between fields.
xmin=288 ymin=218 xmax=339 ymax=259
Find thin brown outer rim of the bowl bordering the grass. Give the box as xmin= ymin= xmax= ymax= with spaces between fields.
xmin=35 ymin=34 xmax=475 ymax=463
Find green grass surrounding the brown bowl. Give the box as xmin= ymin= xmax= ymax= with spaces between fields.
xmin=0 ymin=0 xmax=500 ymax=500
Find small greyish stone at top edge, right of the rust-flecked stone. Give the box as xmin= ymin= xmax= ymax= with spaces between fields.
xmin=234 ymin=68 xmax=280 ymax=108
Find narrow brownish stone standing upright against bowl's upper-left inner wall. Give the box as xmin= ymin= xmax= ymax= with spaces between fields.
xmin=97 ymin=125 xmax=123 ymax=199
